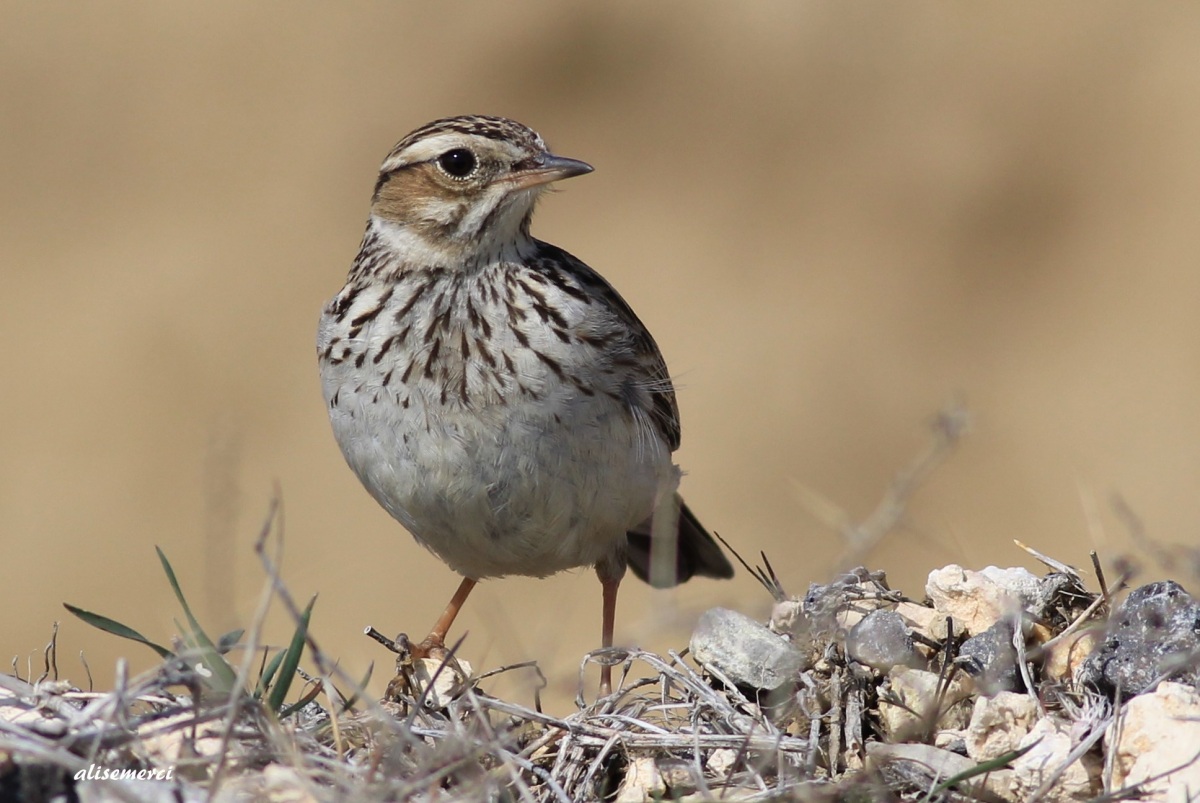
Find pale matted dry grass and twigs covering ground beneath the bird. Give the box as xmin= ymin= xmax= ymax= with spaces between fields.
xmin=0 ymin=554 xmax=1112 ymax=802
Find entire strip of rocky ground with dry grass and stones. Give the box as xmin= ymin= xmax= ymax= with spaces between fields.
xmin=0 ymin=537 xmax=1200 ymax=803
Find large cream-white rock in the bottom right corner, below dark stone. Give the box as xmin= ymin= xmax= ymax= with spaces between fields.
xmin=1106 ymin=682 xmax=1200 ymax=803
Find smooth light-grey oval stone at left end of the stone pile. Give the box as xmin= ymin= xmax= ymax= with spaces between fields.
xmin=690 ymin=607 xmax=804 ymax=691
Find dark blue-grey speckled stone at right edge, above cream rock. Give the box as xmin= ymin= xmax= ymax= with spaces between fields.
xmin=1080 ymin=580 xmax=1200 ymax=700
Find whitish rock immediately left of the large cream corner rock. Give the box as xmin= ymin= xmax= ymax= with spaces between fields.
xmin=1012 ymin=717 xmax=1100 ymax=803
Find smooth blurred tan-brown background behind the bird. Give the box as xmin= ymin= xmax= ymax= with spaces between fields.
xmin=0 ymin=0 xmax=1200 ymax=709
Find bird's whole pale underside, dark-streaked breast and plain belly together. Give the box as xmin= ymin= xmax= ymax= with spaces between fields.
xmin=318 ymin=231 xmax=678 ymax=579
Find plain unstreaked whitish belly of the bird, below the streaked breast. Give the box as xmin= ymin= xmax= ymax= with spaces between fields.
xmin=326 ymin=377 xmax=678 ymax=579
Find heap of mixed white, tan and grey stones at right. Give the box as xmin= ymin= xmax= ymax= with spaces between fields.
xmin=676 ymin=564 xmax=1200 ymax=803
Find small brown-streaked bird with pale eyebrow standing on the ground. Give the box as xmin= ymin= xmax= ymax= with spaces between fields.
xmin=317 ymin=115 xmax=733 ymax=694
